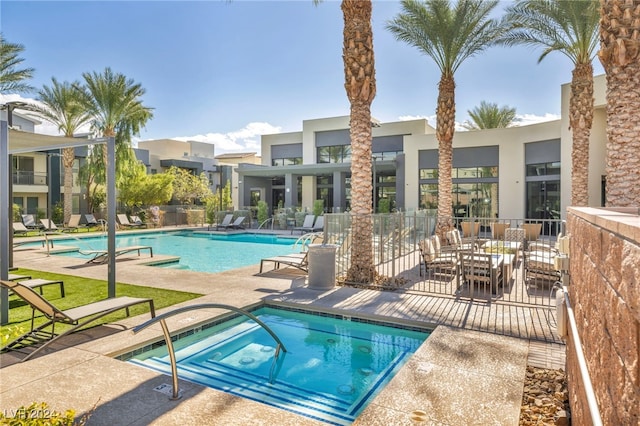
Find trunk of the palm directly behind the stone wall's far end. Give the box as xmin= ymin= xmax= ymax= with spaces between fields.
xmin=569 ymin=62 xmax=594 ymax=207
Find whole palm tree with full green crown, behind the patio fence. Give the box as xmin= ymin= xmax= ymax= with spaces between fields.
xmin=387 ymin=0 xmax=506 ymax=236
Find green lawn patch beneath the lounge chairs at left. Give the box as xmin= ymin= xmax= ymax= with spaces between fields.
xmin=0 ymin=268 xmax=202 ymax=340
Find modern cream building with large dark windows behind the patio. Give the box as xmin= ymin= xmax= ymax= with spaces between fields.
xmin=236 ymin=75 xmax=606 ymax=218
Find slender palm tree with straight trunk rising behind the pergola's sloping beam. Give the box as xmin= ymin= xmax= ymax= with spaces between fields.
xmin=35 ymin=77 xmax=90 ymax=223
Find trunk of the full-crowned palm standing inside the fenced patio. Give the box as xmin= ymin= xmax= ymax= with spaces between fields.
xmin=436 ymin=75 xmax=456 ymax=241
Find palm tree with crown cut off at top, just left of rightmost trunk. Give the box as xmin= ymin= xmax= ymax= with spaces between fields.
xmin=503 ymin=0 xmax=599 ymax=206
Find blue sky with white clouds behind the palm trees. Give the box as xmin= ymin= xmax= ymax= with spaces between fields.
xmin=0 ymin=0 xmax=603 ymax=155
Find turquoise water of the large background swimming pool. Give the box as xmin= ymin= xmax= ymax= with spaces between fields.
xmin=45 ymin=231 xmax=300 ymax=272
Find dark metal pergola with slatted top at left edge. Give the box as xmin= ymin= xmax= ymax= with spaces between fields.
xmin=0 ymin=108 xmax=116 ymax=324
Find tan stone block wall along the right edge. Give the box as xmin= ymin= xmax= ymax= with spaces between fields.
xmin=567 ymin=208 xmax=640 ymax=425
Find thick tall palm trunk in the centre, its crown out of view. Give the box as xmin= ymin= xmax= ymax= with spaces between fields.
xmin=341 ymin=0 xmax=376 ymax=283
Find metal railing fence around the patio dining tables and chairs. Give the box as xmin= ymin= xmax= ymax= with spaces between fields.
xmin=324 ymin=215 xmax=564 ymax=307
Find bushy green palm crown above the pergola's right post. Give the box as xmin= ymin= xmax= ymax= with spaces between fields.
xmin=74 ymin=67 xmax=153 ymax=182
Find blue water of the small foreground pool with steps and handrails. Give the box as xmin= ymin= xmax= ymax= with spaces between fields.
xmin=123 ymin=307 xmax=429 ymax=425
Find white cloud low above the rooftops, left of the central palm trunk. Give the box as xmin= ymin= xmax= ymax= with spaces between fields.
xmin=171 ymin=122 xmax=282 ymax=155
